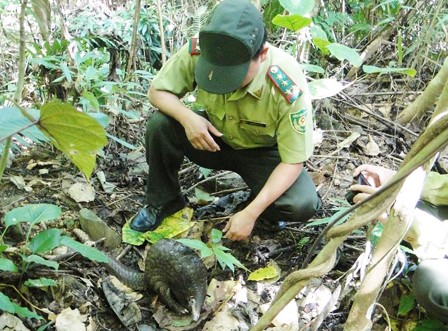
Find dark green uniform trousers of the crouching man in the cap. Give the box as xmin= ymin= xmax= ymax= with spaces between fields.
xmin=146 ymin=112 xmax=320 ymax=222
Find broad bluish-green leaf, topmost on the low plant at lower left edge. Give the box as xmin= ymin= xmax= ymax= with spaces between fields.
xmin=5 ymin=203 xmax=61 ymax=226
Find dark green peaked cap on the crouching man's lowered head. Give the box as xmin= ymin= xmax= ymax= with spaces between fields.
xmin=195 ymin=0 xmax=264 ymax=94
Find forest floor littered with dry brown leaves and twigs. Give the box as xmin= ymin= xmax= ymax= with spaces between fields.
xmin=0 ymin=81 xmax=442 ymax=331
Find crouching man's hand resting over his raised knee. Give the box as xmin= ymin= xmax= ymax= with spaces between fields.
xmin=181 ymin=112 xmax=222 ymax=152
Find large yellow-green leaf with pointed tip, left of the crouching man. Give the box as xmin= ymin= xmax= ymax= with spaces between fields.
xmin=39 ymin=101 xmax=107 ymax=178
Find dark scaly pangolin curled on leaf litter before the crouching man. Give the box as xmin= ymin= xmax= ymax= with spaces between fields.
xmin=105 ymin=239 xmax=207 ymax=321
